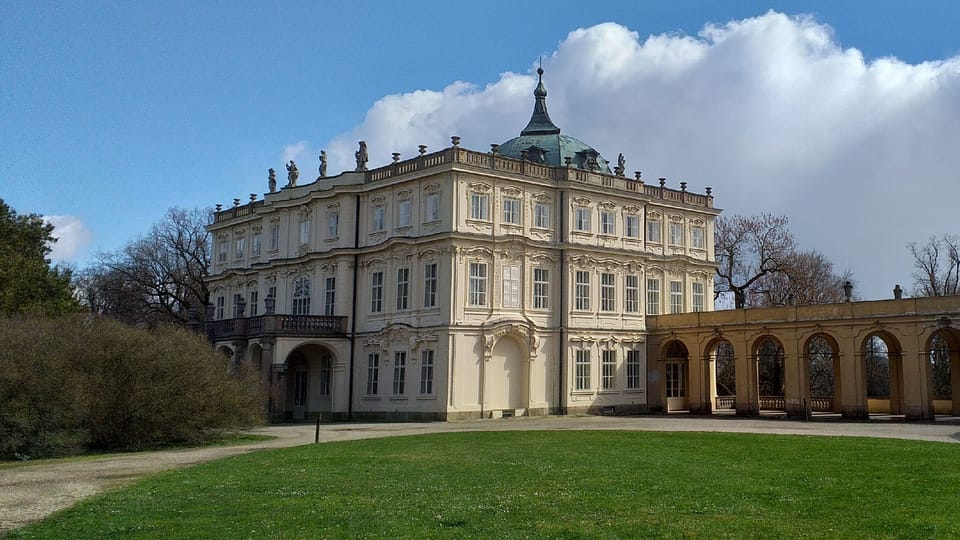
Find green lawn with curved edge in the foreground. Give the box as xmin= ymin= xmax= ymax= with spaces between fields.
xmin=10 ymin=431 xmax=960 ymax=538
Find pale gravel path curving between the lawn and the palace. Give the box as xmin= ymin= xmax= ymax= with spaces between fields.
xmin=0 ymin=416 xmax=960 ymax=536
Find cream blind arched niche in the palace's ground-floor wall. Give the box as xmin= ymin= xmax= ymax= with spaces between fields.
xmin=484 ymin=335 xmax=529 ymax=414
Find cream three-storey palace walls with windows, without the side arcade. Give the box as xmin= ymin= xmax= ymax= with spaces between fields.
xmin=208 ymin=78 xmax=719 ymax=419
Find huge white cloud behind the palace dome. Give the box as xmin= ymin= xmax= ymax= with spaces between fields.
xmin=316 ymin=12 xmax=960 ymax=298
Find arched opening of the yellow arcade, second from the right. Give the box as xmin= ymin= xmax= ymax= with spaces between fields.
xmin=860 ymin=332 xmax=903 ymax=414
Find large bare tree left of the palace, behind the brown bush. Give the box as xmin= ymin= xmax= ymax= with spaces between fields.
xmin=80 ymin=208 xmax=211 ymax=325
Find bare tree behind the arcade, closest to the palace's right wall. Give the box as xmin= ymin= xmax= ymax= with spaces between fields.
xmin=714 ymin=214 xmax=795 ymax=309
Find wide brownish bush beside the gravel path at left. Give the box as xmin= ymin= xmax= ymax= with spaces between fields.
xmin=0 ymin=315 xmax=263 ymax=459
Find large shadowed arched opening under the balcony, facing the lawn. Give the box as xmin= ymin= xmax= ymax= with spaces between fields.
xmin=284 ymin=344 xmax=334 ymax=421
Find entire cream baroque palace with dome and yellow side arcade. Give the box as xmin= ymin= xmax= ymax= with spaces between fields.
xmin=207 ymin=70 xmax=960 ymax=420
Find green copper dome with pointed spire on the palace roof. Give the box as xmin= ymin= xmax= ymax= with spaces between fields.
xmin=498 ymin=68 xmax=610 ymax=174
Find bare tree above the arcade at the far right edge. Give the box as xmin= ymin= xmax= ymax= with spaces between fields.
xmin=907 ymin=234 xmax=960 ymax=296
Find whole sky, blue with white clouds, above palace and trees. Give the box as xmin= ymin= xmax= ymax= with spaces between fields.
xmin=0 ymin=1 xmax=960 ymax=298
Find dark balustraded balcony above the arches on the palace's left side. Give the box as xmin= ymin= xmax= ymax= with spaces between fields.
xmin=207 ymin=314 xmax=347 ymax=341
